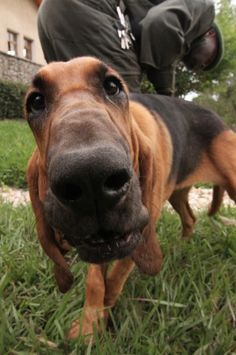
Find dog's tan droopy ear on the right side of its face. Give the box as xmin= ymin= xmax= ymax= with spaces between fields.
xmin=129 ymin=115 xmax=162 ymax=275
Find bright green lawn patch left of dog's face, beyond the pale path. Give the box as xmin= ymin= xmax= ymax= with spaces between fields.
xmin=0 ymin=120 xmax=34 ymax=188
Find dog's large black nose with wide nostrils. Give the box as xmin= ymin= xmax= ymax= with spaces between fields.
xmin=49 ymin=146 xmax=131 ymax=210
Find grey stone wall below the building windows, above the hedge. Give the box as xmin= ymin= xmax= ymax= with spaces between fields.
xmin=0 ymin=51 xmax=41 ymax=84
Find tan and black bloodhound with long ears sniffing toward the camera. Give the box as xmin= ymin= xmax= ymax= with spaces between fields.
xmin=25 ymin=57 xmax=236 ymax=338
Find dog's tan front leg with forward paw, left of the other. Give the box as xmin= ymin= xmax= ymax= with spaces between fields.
xmin=68 ymin=264 xmax=107 ymax=340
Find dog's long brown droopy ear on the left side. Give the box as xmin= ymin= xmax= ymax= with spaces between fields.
xmin=27 ymin=149 xmax=73 ymax=292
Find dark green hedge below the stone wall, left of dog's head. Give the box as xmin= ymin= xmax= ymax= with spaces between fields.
xmin=0 ymin=80 xmax=27 ymax=119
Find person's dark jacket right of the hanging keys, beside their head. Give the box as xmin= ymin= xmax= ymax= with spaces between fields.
xmin=124 ymin=0 xmax=215 ymax=70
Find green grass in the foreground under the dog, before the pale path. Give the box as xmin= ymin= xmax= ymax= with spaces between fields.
xmin=0 ymin=204 xmax=236 ymax=355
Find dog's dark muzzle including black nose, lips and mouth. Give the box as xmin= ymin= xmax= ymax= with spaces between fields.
xmin=44 ymin=145 xmax=148 ymax=263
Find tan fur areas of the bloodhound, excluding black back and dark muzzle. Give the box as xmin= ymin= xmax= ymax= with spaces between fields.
xmin=24 ymin=58 xmax=236 ymax=339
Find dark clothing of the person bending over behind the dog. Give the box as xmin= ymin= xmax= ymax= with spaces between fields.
xmin=38 ymin=0 xmax=214 ymax=92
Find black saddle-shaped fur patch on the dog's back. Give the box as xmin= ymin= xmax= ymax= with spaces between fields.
xmin=130 ymin=94 xmax=226 ymax=183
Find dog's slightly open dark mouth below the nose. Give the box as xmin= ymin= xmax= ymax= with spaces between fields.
xmin=67 ymin=231 xmax=142 ymax=264
